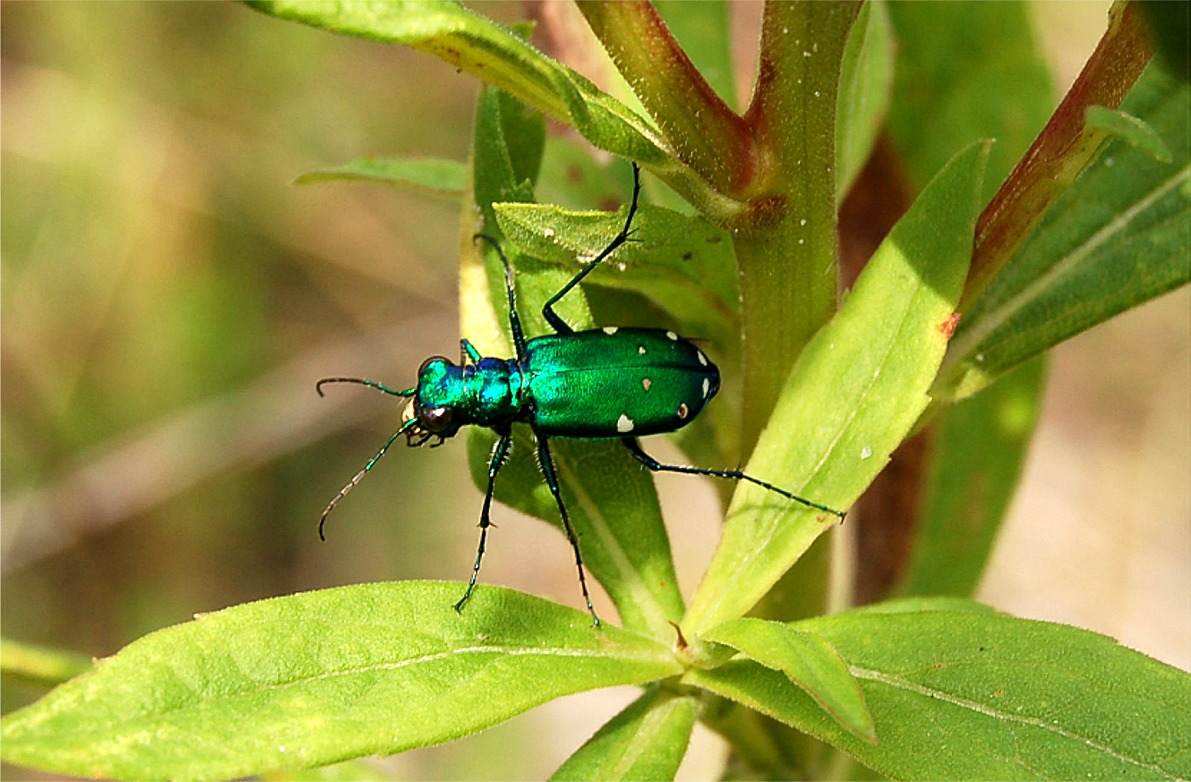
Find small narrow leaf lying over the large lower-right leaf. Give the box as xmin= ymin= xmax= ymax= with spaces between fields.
xmin=703 ymin=619 xmax=877 ymax=742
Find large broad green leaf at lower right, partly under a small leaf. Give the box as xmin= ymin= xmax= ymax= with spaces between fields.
xmin=686 ymin=601 xmax=1191 ymax=780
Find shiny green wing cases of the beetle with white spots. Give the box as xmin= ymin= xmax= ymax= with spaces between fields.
xmin=524 ymin=326 xmax=719 ymax=439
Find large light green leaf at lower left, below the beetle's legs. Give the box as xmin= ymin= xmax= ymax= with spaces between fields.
xmin=0 ymin=582 xmax=679 ymax=780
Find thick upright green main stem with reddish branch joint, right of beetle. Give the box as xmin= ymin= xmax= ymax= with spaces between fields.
xmin=729 ymin=2 xmax=860 ymax=453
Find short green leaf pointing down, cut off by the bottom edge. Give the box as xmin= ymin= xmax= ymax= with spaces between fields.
xmin=550 ymin=688 xmax=699 ymax=782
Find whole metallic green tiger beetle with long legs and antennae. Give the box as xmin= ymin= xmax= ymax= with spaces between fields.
xmin=316 ymin=163 xmax=844 ymax=626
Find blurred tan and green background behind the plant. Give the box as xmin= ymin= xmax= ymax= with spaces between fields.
xmin=0 ymin=2 xmax=1191 ymax=778
